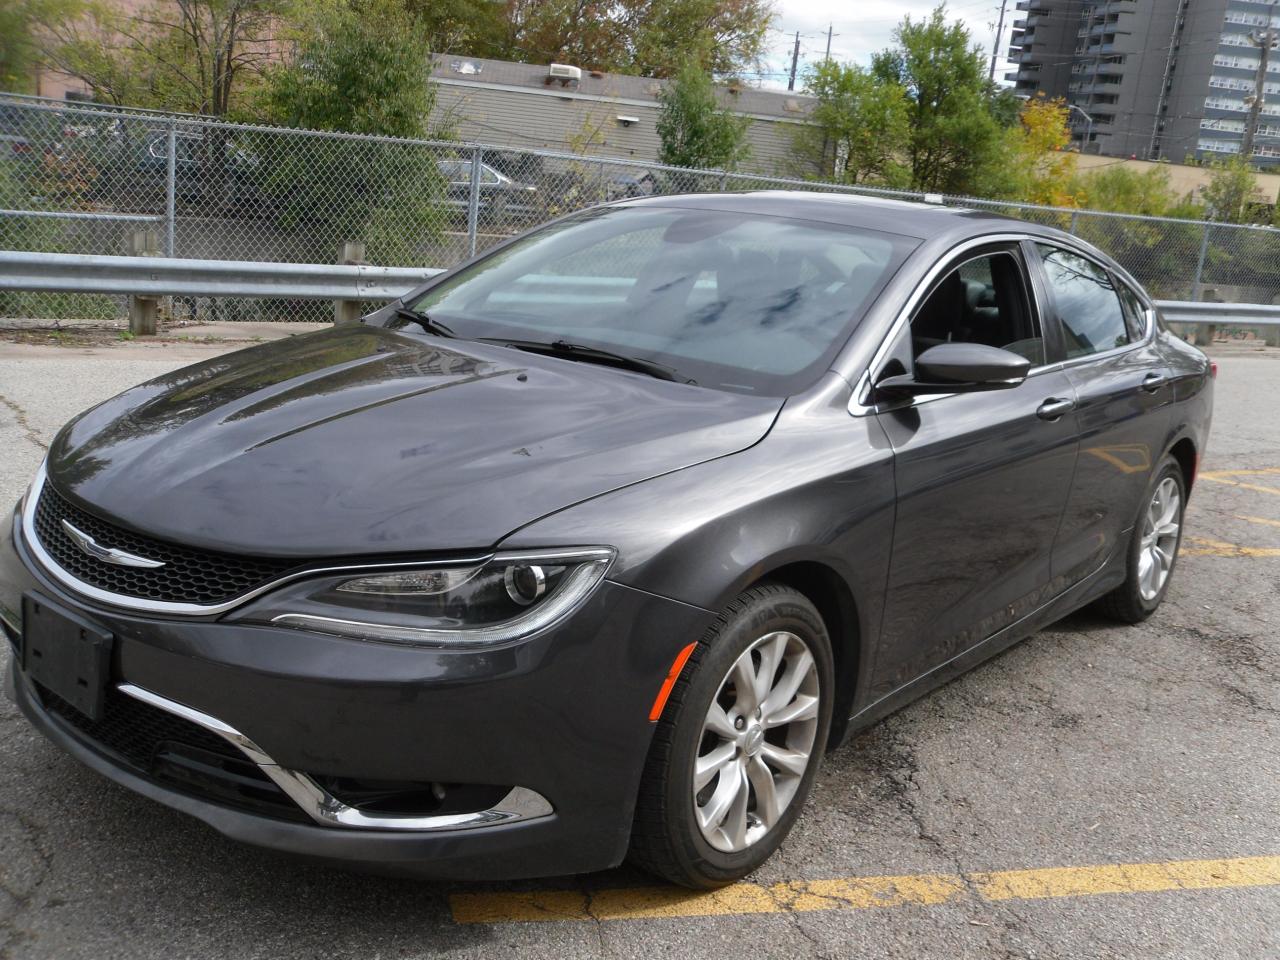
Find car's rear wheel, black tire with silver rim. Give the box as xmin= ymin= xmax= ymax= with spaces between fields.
xmin=1097 ymin=457 xmax=1187 ymax=623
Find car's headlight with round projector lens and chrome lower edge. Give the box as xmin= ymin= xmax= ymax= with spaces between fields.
xmin=236 ymin=548 xmax=613 ymax=646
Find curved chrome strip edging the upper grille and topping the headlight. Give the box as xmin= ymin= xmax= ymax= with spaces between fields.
xmin=20 ymin=463 xmax=496 ymax=617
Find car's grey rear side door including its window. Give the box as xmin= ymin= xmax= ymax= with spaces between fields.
xmin=1028 ymin=241 xmax=1172 ymax=586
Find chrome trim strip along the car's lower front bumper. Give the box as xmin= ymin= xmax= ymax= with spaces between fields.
xmin=116 ymin=684 xmax=553 ymax=832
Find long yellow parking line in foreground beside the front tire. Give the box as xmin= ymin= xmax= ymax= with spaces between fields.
xmin=449 ymin=856 xmax=1280 ymax=924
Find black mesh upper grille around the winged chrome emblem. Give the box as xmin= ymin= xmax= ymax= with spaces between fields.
xmin=35 ymin=481 xmax=297 ymax=605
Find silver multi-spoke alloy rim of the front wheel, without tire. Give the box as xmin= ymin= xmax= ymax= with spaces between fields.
xmin=692 ymin=631 xmax=820 ymax=852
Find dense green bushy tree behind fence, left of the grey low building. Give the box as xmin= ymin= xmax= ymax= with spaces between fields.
xmin=246 ymin=0 xmax=444 ymax=264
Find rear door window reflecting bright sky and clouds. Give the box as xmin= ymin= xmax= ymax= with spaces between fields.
xmin=1036 ymin=243 xmax=1130 ymax=358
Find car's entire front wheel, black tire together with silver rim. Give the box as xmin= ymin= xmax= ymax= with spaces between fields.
xmin=628 ymin=584 xmax=835 ymax=890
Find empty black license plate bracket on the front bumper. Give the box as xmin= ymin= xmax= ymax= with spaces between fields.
xmin=22 ymin=594 xmax=114 ymax=721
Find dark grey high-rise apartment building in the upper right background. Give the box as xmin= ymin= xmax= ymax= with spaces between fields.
xmin=1005 ymin=0 xmax=1280 ymax=165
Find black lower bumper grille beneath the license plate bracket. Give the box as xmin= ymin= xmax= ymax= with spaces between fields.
xmin=36 ymin=684 xmax=311 ymax=823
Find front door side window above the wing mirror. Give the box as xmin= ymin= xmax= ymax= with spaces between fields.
xmin=911 ymin=253 xmax=1044 ymax=365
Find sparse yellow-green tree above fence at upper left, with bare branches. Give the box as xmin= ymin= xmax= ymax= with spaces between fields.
xmin=46 ymin=0 xmax=287 ymax=116
